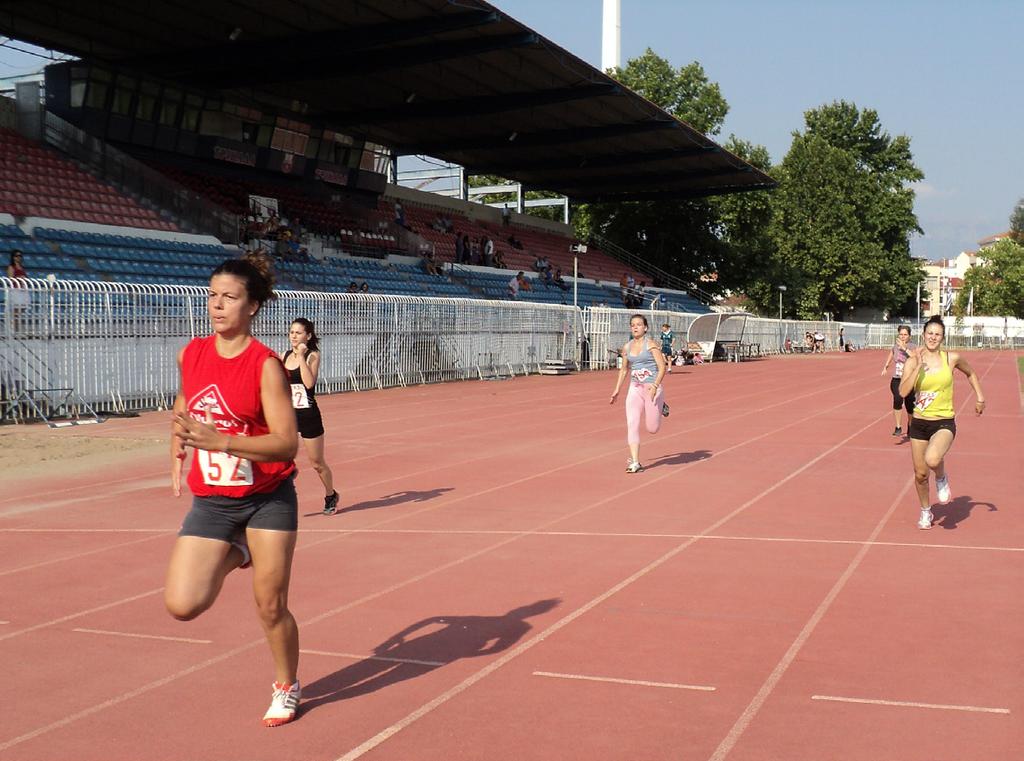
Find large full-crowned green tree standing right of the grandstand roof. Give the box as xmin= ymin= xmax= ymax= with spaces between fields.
xmin=771 ymin=101 xmax=924 ymax=318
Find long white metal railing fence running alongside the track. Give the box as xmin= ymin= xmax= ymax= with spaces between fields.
xmin=0 ymin=278 xmax=1024 ymax=412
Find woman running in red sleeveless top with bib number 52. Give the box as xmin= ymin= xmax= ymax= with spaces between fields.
xmin=164 ymin=255 xmax=300 ymax=726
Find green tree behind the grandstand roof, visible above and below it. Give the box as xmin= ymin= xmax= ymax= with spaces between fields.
xmin=573 ymin=48 xmax=729 ymax=290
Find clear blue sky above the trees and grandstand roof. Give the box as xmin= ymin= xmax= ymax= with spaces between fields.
xmin=0 ymin=0 xmax=1024 ymax=259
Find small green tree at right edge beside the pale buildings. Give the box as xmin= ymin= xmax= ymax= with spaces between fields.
xmin=953 ymin=239 xmax=1024 ymax=318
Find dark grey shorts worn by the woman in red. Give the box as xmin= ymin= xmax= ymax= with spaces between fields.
xmin=178 ymin=474 xmax=299 ymax=542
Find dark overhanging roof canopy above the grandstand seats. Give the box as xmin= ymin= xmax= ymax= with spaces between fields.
xmin=0 ymin=0 xmax=775 ymax=201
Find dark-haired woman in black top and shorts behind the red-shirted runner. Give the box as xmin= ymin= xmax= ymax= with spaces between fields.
xmin=281 ymin=318 xmax=338 ymax=515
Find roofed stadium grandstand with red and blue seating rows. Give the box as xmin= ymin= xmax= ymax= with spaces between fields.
xmin=0 ymin=0 xmax=772 ymax=301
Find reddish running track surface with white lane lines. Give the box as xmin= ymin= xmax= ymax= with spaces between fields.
xmin=0 ymin=351 xmax=1024 ymax=761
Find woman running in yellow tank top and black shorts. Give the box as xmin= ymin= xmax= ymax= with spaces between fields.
xmin=899 ymin=315 xmax=985 ymax=529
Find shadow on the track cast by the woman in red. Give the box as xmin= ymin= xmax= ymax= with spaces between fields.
xmin=302 ymin=598 xmax=561 ymax=713
